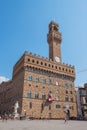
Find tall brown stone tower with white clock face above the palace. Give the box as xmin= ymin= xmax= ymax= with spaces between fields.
xmin=47 ymin=21 xmax=62 ymax=62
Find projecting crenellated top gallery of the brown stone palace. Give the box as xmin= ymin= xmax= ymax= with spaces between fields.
xmin=13 ymin=51 xmax=75 ymax=78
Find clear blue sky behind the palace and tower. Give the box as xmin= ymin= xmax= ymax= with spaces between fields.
xmin=0 ymin=0 xmax=87 ymax=86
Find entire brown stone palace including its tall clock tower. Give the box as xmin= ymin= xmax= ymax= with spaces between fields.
xmin=0 ymin=22 xmax=77 ymax=119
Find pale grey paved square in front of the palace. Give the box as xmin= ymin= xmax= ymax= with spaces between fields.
xmin=0 ymin=120 xmax=87 ymax=130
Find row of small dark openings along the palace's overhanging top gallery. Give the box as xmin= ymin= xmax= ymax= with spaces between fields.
xmin=28 ymin=58 xmax=74 ymax=73
